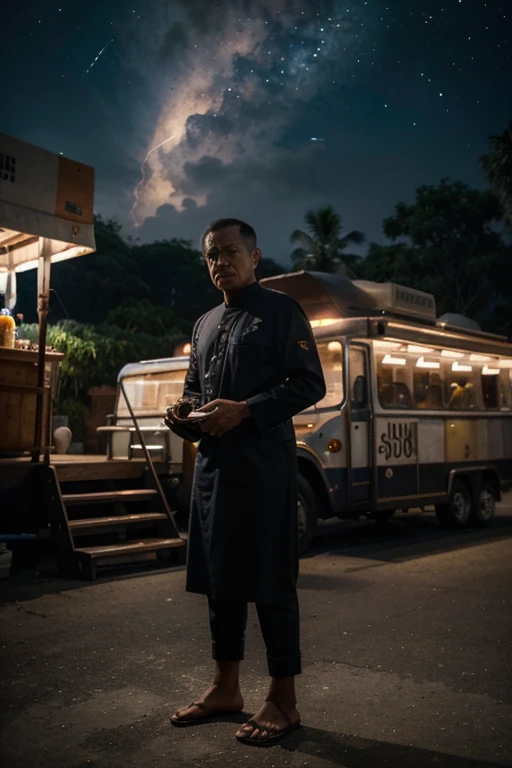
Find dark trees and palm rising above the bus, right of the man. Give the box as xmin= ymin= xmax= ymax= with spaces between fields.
xmin=291 ymin=123 xmax=512 ymax=336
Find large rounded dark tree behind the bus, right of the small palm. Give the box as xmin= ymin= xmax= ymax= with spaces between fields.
xmin=362 ymin=179 xmax=510 ymax=330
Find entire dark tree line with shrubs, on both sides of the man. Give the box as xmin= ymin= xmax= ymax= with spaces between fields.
xmin=16 ymin=123 xmax=512 ymax=412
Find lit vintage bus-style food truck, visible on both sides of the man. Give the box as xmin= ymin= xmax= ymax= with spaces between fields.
xmin=100 ymin=271 xmax=512 ymax=550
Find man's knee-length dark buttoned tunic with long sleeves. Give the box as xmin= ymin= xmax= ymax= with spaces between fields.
xmin=184 ymin=283 xmax=325 ymax=603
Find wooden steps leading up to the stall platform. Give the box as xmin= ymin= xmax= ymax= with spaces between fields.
xmin=43 ymin=460 xmax=185 ymax=580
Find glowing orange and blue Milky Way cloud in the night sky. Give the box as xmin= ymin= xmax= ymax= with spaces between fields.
xmin=127 ymin=0 xmax=369 ymax=225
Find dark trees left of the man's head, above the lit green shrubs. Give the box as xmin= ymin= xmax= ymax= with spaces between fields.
xmin=16 ymin=216 xmax=283 ymax=333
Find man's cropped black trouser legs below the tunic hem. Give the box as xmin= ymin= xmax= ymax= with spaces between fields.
xmin=208 ymin=587 xmax=301 ymax=678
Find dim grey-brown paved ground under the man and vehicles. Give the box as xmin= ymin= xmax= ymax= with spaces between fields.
xmin=0 ymin=498 xmax=512 ymax=768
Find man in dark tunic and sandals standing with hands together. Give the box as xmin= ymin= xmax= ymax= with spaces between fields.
xmin=171 ymin=219 xmax=325 ymax=746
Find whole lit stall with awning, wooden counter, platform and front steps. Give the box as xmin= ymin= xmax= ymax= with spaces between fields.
xmin=0 ymin=133 xmax=184 ymax=578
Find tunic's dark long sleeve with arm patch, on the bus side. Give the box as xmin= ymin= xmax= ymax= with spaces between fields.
xmin=247 ymin=300 xmax=326 ymax=433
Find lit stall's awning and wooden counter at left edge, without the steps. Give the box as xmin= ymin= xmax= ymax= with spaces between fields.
xmin=0 ymin=134 xmax=95 ymax=463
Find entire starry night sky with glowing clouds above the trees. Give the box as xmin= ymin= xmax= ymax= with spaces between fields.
xmin=0 ymin=0 xmax=512 ymax=264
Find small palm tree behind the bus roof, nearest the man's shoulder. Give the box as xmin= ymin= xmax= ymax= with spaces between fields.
xmin=290 ymin=205 xmax=364 ymax=277
